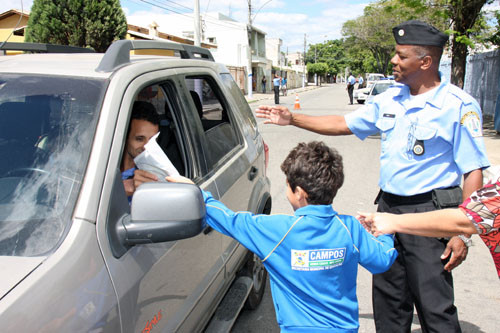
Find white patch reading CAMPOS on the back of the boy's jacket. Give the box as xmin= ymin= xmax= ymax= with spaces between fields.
xmin=290 ymin=247 xmax=345 ymax=271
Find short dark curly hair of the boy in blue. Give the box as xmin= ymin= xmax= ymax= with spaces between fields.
xmin=281 ymin=141 xmax=344 ymax=205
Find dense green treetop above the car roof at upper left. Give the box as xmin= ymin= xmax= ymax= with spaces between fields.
xmin=26 ymin=0 xmax=127 ymax=52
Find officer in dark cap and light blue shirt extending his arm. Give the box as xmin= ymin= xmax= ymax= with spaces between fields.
xmin=256 ymin=20 xmax=489 ymax=333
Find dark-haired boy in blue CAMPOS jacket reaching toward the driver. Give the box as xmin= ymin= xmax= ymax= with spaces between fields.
xmin=167 ymin=141 xmax=397 ymax=332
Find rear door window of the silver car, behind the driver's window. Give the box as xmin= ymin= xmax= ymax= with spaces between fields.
xmin=185 ymin=76 xmax=240 ymax=168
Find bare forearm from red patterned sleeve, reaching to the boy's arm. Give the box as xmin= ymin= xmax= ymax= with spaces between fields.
xmin=357 ymin=208 xmax=478 ymax=237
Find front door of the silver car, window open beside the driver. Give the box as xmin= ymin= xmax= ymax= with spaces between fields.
xmin=97 ymin=69 xmax=224 ymax=332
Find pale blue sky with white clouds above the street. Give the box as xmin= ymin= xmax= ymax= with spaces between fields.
xmin=0 ymin=0 xmax=500 ymax=52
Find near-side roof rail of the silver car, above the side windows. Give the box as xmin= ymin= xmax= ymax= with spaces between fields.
xmin=96 ymin=39 xmax=214 ymax=72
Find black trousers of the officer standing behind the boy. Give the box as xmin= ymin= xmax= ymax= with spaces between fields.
xmin=372 ymin=192 xmax=461 ymax=333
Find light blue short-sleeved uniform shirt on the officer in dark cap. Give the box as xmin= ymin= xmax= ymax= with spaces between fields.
xmin=345 ymin=76 xmax=489 ymax=196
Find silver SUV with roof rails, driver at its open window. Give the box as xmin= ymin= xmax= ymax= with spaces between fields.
xmin=0 ymin=41 xmax=271 ymax=332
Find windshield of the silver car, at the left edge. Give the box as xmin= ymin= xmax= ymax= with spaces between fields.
xmin=0 ymin=74 xmax=107 ymax=256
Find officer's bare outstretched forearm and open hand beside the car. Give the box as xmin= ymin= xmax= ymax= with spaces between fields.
xmin=255 ymin=105 xmax=352 ymax=135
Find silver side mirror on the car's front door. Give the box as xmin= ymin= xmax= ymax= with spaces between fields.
xmin=106 ymin=169 xmax=205 ymax=258
